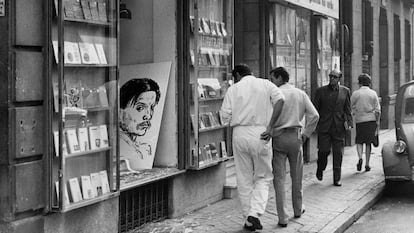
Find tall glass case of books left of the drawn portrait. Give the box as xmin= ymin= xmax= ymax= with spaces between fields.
xmin=51 ymin=0 xmax=118 ymax=211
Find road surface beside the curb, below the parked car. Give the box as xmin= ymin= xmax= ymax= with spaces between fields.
xmin=345 ymin=184 xmax=414 ymax=233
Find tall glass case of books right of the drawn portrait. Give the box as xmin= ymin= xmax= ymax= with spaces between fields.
xmin=187 ymin=0 xmax=233 ymax=169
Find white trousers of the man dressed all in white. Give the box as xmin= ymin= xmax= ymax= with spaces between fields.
xmin=233 ymin=126 xmax=273 ymax=217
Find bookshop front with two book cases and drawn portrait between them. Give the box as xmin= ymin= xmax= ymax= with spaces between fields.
xmin=0 ymin=0 xmax=234 ymax=233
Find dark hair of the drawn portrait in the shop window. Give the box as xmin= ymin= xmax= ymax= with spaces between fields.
xmin=119 ymin=78 xmax=161 ymax=109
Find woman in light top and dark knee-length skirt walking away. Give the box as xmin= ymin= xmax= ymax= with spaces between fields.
xmin=351 ymin=73 xmax=381 ymax=172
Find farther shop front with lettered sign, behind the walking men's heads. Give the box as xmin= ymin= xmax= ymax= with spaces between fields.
xmin=234 ymin=0 xmax=341 ymax=161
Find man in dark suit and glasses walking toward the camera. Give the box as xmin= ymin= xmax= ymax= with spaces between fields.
xmin=313 ymin=70 xmax=352 ymax=186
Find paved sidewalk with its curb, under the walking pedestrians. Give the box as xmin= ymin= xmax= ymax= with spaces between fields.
xmin=134 ymin=130 xmax=395 ymax=233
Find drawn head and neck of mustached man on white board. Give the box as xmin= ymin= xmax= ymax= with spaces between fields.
xmin=119 ymin=78 xmax=161 ymax=170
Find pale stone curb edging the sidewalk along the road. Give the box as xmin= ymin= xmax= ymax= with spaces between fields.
xmin=320 ymin=181 xmax=385 ymax=233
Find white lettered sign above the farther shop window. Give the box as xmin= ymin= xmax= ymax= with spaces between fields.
xmin=270 ymin=0 xmax=339 ymax=19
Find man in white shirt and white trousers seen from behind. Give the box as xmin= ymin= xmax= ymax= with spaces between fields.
xmin=220 ymin=64 xmax=284 ymax=231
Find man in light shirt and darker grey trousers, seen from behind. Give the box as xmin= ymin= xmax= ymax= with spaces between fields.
xmin=268 ymin=67 xmax=319 ymax=227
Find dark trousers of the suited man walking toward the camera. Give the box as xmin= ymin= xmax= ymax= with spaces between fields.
xmin=318 ymin=129 xmax=345 ymax=182
